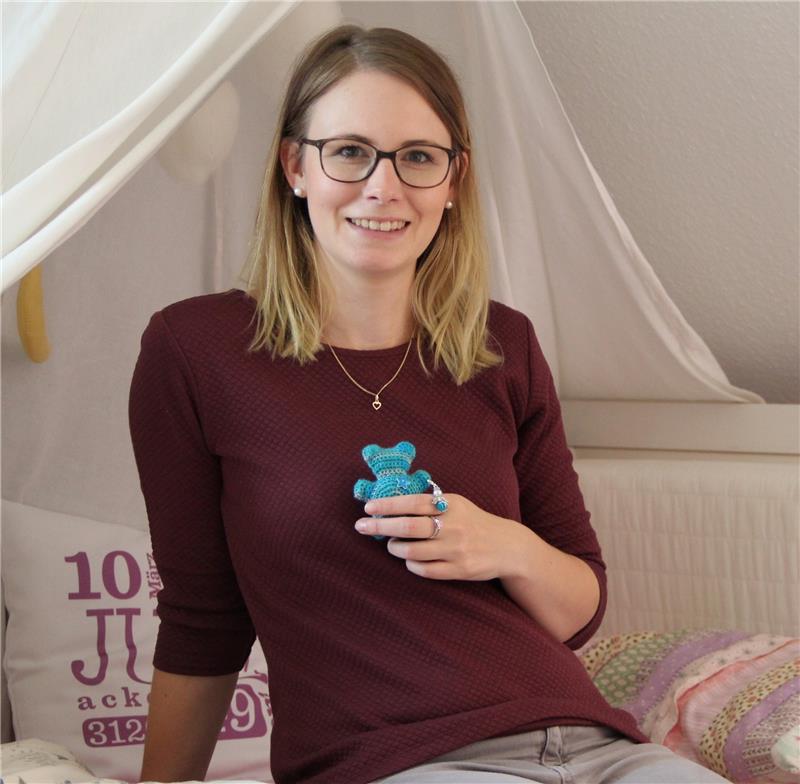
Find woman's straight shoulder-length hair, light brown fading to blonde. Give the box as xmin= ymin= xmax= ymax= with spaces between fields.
xmin=234 ymin=25 xmax=502 ymax=384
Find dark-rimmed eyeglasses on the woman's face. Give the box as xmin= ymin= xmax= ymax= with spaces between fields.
xmin=299 ymin=138 xmax=458 ymax=188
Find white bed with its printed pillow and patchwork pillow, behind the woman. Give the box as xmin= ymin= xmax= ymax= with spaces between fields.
xmin=2 ymin=401 xmax=800 ymax=784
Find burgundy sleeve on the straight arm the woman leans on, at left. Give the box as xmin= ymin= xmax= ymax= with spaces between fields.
xmin=128 ymin=312 xmax=255 ymax=675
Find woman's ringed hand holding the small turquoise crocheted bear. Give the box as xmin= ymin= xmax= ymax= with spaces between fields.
xmin=356 ymin=493 xmax=530 ymax=580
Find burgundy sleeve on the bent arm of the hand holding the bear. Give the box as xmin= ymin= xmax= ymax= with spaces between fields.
xmin=514 ymin=318 xmax=607 ymax=649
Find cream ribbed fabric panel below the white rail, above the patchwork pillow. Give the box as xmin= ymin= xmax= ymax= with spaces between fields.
xmin=574 ymin=457 xmax=800 ymax=636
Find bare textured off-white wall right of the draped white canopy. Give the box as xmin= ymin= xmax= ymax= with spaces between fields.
xmin=520 ymin=2 xmax=800 ymax=403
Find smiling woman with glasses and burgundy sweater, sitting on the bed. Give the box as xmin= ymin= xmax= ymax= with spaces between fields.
xmin=130 ymin=21 xmax=722 ymax=784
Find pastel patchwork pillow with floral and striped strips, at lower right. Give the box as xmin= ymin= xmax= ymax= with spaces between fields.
xmin=578 ymin=630 xmax=800 ymax=784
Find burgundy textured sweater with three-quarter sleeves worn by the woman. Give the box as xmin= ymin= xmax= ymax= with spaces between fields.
xmin=129 ymin=290 xmax=646 ymax=784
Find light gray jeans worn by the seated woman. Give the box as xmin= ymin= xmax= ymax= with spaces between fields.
xmin=373 ymin=726 xmax=727 ymax=784
